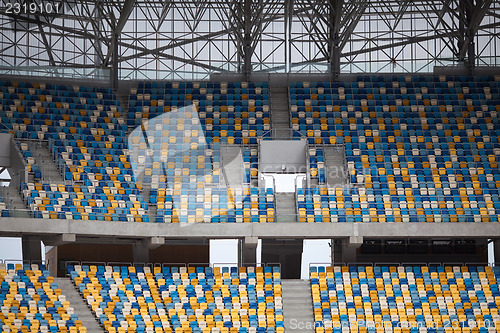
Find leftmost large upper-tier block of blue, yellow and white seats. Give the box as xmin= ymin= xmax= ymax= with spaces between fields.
xmin=0 ymin=82 xmax=148 ymax=221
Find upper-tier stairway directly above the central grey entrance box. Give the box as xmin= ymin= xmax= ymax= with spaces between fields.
xmin=269 ymin=86 xmax=291 ymax=140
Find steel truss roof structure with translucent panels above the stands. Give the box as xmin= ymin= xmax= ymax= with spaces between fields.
xmin=0 ymin=0 xmax=500 ymax=80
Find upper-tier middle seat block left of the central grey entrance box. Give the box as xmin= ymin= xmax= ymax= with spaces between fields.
xmin=129 ymin=82 xmax=274 ymax=223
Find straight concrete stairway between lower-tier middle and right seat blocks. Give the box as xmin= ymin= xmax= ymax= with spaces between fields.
xmin=281 ymin=279 xmax=314 ymax=333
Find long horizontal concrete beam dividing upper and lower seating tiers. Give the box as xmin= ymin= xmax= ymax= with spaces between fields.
xmin=0 ymin=217 xmax=500 ymax=241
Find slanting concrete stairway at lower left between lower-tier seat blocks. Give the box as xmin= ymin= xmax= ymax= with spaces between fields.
xmin=54 ymin=278 xmax=104 ymax=333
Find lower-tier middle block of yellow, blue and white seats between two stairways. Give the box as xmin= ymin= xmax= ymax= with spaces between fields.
xmin=68 ymin=265 xmax=283 ymax=333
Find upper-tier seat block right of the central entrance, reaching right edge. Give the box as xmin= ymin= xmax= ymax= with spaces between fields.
xmin=290 ymin=76 xmax=500 ymax=222
